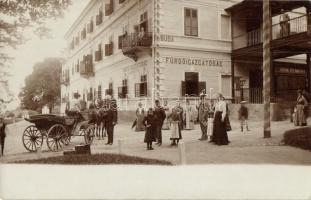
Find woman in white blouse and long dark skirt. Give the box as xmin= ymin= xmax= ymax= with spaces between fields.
xmin=212 ymin=94 xmax=230 ymax=145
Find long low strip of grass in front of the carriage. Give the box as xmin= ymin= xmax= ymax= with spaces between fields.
xmin=14 ymin=154 xmax=172 ymax=165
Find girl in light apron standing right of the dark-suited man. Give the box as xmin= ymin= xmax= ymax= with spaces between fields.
xmin=168 ymin=106 xmax=182 ymax=146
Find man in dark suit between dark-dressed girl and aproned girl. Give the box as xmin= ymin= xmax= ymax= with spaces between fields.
xmin=154 ymin=100 xmax=166 ymax=146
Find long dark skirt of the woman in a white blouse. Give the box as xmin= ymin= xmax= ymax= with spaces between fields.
xmin=212 ymin=111 xmax=229 ymax=145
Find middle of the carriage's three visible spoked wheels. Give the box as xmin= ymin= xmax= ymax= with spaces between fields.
xmin=46 ymin=124 xmax=69 ymax=151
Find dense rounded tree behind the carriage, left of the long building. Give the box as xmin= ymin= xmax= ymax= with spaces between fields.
xmin=19 ymin=58 xmax=62 ymax=111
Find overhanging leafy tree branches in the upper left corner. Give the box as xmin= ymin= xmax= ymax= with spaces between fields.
xmin=0 ymin=0 xmax=71 ymax=76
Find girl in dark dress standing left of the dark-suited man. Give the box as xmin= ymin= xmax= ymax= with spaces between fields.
xmin=142 ymin=108 xmax=157 ymax=150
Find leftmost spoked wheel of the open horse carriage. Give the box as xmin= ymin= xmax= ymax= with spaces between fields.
xmin=22 ymin=125 xmax=43 ymax=152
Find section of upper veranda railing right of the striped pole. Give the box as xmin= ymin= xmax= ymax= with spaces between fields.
xmin=272 ymin=15 xmax=308 ymax=40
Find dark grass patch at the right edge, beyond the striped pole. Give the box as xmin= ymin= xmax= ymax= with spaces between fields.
xmin=283 ymin=127 xmax=311 ymax=150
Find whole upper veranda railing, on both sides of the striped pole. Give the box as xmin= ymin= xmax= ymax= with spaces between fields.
xmin=233 ymin=15 xmax=308 ymax=49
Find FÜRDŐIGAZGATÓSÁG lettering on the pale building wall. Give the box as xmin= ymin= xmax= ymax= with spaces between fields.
xmin=164 ymin=56 xmax=223 ymax=67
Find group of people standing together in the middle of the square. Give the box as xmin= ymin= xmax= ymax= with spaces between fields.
xmin=133 ymin=94 xmax=231 ymax=150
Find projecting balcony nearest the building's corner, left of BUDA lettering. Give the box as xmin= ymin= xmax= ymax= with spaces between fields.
xmin=122 ymin=32 xmax=152 ymax=61
